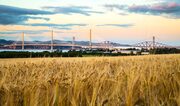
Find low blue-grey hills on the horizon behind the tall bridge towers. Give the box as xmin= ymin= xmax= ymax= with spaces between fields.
xmin=0 ymin=39 xmax=130 ymax=46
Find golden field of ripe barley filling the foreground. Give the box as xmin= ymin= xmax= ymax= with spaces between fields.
xmin=0 ymin=54 xmax=180 ymax=106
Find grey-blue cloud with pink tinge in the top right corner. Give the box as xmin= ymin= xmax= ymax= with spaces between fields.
xmin=104 ymin=2 xmax=180 ymax=18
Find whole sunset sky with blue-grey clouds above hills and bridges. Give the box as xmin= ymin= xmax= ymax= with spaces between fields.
xmin=0 ymin=0 xmax=180 ymax=46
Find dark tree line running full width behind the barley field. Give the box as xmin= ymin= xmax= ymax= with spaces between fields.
xmin=0 ymin=48 xmax=180 ymax=58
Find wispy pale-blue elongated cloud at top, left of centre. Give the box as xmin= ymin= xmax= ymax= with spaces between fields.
xmin=43 ymin=6 xmax=103 ymax=16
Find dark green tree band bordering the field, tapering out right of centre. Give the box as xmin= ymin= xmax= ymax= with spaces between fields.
xmin=0 ymin=50 xmax=134 ymax=58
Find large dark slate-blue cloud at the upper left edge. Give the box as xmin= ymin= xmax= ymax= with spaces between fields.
xmin=0 ymin=5 xmax=54 ymax=25
